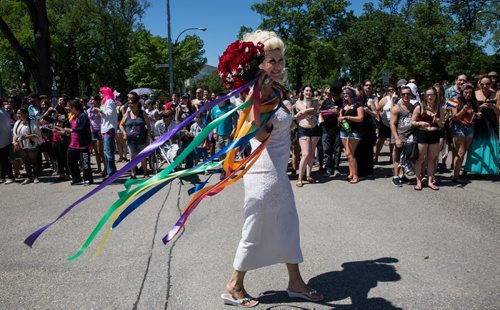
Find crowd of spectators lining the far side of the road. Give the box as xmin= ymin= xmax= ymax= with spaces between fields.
xmin=0 ymin=72 xmax=500 ymax=190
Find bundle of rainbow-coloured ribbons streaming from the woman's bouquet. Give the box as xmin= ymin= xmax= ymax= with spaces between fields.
xmin=24 ymin=79 xmax=282 ymax=260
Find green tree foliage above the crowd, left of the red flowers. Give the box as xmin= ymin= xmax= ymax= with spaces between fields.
xmin=0 ymin=0 xmax=206 ymax=97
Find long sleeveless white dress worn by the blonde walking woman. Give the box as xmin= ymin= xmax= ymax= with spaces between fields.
xmin=233 ymin=109 xmax=303 ymax=271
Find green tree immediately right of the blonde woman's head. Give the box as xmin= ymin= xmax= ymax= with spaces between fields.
xmin=252 ymin=0 xmax=352 ymax=89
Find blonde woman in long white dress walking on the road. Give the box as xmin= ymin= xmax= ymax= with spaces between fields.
xmin=221 ymin=30 xmax=323 ymax=307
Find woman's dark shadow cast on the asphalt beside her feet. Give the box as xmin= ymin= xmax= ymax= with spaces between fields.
xmin=259 ymin=257 xmax=401 ymax=310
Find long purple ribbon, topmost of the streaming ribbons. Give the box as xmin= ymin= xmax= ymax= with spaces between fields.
xmin=24 ymin=78 xmax=257 ymax=247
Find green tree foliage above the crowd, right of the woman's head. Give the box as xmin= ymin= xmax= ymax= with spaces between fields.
xmin=248 ymin=0 xmax=499 ymax=89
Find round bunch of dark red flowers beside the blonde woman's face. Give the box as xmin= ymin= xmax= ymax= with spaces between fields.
xmin=218 ymin=40 xmax=264 ymax=89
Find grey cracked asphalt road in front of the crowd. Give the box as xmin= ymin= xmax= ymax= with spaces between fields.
xmin=0 ymin=149 xmax=500 ymax=309
